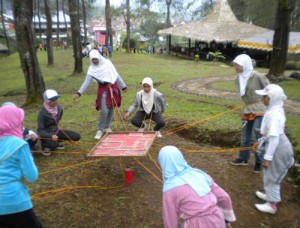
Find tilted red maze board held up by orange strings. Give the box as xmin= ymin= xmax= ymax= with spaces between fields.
xmin=87 ymin=132 xmax=156 ymax=157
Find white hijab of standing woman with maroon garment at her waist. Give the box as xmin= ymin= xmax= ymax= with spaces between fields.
xmin=87 ymin=49 xmax=119 ymax=84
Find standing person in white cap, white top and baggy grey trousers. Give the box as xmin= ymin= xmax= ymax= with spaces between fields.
xmin=255 ymin=84 xmax=294 ymax=214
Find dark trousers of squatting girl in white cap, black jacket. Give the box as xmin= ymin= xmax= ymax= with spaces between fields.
xmin=41 ymin=129 xmax=80 ymax=150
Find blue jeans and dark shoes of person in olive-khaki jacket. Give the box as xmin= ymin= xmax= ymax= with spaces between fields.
xmin=239 ymin=116 xmax=263 ymax=164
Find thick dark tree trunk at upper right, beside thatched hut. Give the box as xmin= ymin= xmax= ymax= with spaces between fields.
xmin=268 ymin=0 xmax=295 ymax=81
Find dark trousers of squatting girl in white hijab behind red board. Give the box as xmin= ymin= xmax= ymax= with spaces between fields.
xmin=131 ymin=111 xmax=166 ymax=131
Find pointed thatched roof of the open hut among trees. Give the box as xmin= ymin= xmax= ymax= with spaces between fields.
xmin=158 ymin=0 xmax=270 ymax=43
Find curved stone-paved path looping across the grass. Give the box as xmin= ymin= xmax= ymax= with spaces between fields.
xmin=172 ymin=75 xmax=300 ymax=115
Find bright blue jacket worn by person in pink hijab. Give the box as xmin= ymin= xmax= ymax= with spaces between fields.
xmin=0 ymin=136 xmax=38 ymax=215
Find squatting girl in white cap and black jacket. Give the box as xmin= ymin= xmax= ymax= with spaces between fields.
xmin=37 ymin=89 xmax=80 ymax=156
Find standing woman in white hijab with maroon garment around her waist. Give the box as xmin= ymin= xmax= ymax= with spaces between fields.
xmin=73 ymin=50 xmax=127 ymax=139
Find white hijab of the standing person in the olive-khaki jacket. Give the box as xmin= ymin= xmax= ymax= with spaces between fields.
xmin=233 ymin=54 xmax=253 ymax=96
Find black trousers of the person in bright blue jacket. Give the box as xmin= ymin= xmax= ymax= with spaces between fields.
xmin=0 ymin=208 xmax=43 ymax=228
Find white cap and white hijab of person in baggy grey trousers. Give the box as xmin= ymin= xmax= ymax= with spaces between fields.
xmin=255 ymin=84 xmax=287 ymax=136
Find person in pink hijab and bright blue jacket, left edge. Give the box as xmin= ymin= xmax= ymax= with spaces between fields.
xmin=0 ymin=105 xmax=43 ymax=228
